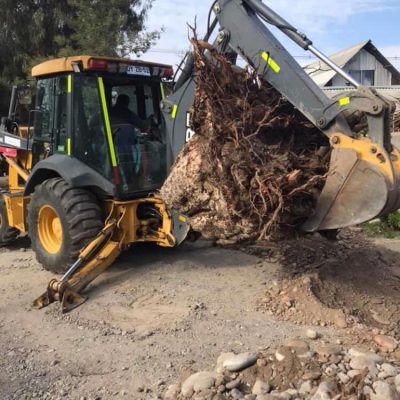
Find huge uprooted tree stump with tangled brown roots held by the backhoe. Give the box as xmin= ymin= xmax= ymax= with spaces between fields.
xmin=161 ymin=39 xmax=330 ymax=243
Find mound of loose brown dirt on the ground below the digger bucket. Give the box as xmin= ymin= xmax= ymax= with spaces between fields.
xmin=255 ymin=233 xmax=400 ymax=336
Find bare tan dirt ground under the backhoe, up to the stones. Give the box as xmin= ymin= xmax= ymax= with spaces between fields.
xmin=0 ymin=233 xmax=400 ymax=400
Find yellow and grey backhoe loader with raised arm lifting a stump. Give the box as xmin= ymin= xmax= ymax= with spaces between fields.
xmin=0 ymin=0 xmax=400 ymax=312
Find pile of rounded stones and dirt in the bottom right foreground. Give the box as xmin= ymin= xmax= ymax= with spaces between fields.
xmin=164 ymin=333 xmax=400 ymax=400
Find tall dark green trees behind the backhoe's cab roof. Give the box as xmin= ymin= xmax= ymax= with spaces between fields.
xmin=0 ymin=0 xmax=160 ymax=83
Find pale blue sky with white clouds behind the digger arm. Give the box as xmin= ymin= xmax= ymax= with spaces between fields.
xmin=143 ymin=0 xmax=400 ymax=69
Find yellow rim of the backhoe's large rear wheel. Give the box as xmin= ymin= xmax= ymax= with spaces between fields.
xmin=37 ymin=205 xmax=63 ymax=254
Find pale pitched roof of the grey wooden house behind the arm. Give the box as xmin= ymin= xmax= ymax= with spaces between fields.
xmin=304 ymin=40 xmax=400 ymax=86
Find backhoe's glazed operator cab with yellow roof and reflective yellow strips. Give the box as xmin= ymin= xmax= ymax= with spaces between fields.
xmin=31 ymin=56 xmax=173 ymax=199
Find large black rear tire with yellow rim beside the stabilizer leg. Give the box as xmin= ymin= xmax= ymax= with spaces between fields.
xmin=28 ymin=178 xmax=104 ymax=273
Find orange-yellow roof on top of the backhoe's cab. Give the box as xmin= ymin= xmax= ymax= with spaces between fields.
xmin=32 ymin=55 xmax=172 ymax=77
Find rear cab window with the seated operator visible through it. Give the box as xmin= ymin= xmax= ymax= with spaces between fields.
xmin=103 ymin=76 xmax=167 ymax=194
